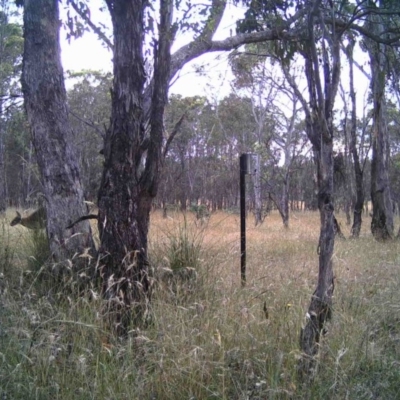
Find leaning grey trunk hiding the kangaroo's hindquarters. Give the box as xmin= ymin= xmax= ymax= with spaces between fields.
xmin=22 ymin=0 xmax=93 ymax=262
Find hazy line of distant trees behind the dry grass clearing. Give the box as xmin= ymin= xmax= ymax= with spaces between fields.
xmin=4 ymin=71 xmax=400 ymax=225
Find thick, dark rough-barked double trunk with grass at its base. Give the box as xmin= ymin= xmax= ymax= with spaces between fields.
xmin=98 ymin=0 xmax=172 ymax=334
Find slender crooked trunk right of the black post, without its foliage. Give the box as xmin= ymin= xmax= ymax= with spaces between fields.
xmin=290 ymin=1 xmax=340 ymax=378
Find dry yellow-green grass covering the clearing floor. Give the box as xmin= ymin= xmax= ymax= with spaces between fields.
xmin=0 ymin=212 xmax=400 ymax=400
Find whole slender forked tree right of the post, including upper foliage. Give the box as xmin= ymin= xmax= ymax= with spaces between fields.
xmin=238 ymin=1 xmax=343 ymax=372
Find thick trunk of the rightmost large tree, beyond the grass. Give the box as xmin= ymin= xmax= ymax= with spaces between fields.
xmin=365 ymin=14 xmax=394 ymax=241
